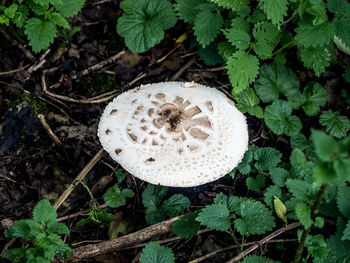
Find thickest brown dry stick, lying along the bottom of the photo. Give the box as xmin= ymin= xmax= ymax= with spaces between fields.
xmin=67 ymin=216 xmax=182 ymax=262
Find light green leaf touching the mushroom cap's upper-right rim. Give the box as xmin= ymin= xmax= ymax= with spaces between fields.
xmin=235 ymin=88 xmax=264 ymax=118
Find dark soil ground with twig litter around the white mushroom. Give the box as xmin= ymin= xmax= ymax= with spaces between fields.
xmin=0 ymin=0 xmax=350 ymax=262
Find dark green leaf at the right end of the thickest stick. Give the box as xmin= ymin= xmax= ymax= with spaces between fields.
xmin=171 ymin=211 xmax=200 ymax=239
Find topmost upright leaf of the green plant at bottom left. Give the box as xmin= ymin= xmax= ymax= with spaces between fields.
xmin=33 ymin=199 xmax=57 ymax=225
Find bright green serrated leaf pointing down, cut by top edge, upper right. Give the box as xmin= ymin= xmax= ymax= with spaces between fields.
xmin=259 ymin=0 xmax=288 ymax=25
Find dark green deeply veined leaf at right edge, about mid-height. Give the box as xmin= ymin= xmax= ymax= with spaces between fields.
xmin=320 ymin=110 xmax=350 ymax=139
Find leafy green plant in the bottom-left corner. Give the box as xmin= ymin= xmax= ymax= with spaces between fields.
xmin=4 ymin=199 xmax=71 ymax=262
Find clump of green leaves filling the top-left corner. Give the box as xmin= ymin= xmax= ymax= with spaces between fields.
xmin=0 ymin=0 xmax=85 ymax=52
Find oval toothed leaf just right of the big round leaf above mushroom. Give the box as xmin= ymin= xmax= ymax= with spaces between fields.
xmin=193 ymin=10 xmax=224 ymax=48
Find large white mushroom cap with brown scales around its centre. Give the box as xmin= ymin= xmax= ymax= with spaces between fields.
xmin=98 ymin=82 xmax=248 ymax=187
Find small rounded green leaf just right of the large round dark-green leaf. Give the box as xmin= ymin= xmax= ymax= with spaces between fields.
xmin=302 ymin=83 xmax=327 ymax=116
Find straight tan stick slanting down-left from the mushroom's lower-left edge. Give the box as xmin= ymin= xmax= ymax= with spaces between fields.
xmin=54 ymin=148 xmax=105 ymax=210
